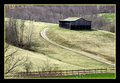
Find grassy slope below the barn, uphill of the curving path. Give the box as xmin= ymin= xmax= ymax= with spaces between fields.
xmin=47 ymin=25 xmax=115 ymax=62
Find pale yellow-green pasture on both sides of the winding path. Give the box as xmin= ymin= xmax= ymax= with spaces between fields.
xmin=6 ymin=17 xmax=115 ymax=75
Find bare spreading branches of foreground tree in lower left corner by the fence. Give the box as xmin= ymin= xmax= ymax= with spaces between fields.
xmin=4 ymin=45 xmax=27 ymax=75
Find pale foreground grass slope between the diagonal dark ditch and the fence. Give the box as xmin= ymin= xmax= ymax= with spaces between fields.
xmin=6 ymin=45 xmax=82 ymax=71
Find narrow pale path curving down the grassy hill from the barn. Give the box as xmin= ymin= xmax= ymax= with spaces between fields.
xmin=41 ymin=28 xmax=115 ymax=65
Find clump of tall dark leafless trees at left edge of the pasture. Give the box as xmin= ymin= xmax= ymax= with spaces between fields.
xmin=5 ymin=18 xmax=25 ymax=47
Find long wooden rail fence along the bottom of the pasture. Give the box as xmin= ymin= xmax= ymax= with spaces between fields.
xmin=5 ymin=69 xmax=115 ymax=77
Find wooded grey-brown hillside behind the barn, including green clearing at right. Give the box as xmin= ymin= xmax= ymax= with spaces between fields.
xmin=5 ymin=4 xmax=116 ymax=33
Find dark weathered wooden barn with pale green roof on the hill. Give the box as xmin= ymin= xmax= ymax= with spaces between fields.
xmin=59 ymin=17 xmax=91 ymax=30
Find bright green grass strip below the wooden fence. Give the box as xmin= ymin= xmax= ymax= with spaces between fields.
xmin=13 ymin=73 xmax=116 ymax=79
